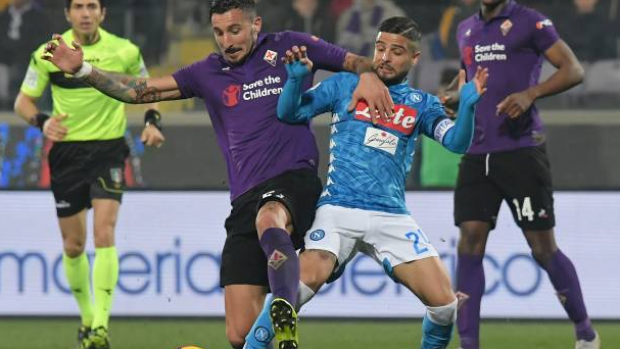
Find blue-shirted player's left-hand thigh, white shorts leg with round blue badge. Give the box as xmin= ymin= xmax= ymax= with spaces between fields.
xmin=300 ymin=205 xmax=368 ymax=282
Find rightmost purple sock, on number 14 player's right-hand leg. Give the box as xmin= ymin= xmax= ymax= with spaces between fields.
xmin=542 ymin=250 xmax=595 ymax=341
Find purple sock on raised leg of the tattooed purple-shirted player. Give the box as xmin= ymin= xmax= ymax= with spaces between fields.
xmin=260 ymin=228 xmax=299 ymax=306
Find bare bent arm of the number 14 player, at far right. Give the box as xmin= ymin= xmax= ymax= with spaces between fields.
xmin=497 ymin=40 xmax=584 ymax=119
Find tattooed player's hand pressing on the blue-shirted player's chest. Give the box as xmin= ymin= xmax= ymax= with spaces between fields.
xmin=347 ymin=72 xmax=394 ymax=125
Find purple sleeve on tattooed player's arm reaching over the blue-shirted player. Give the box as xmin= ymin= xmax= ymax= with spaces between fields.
xmin=288 ymin=32 xmax=347 ymax=71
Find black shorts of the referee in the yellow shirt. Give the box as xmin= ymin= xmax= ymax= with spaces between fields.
xmin=48 ymin=138 xmax=129 ymax=217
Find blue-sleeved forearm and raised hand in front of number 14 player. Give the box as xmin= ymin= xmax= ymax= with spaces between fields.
xmin=443 ymin=67 xmax=489 ymax=154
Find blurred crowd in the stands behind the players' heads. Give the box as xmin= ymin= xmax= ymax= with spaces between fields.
xmin=0 ymin=0 xmax=620 ymax=109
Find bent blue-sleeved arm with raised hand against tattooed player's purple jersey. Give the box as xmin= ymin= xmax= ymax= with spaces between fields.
xmin=277 ymin=46 xmax=334 ymax=123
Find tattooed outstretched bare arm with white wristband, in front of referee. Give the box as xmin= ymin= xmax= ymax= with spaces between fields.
xmin=42 ymin=34 xmax=183 ymax=104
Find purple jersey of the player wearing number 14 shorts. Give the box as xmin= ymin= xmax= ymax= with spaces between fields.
xmin=457 ymin=0 xmax=559 ymax=154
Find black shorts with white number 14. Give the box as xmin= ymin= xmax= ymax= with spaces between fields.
xmin=454 ymin=144 xmax=555 ymax=230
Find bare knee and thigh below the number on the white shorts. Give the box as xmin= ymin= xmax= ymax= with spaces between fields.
xmin=394 ymin=256 xmax=455 ymax=307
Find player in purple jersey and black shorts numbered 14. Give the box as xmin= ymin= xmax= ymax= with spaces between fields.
xmin=446 ymin=0 xmax=600 ymax=349
